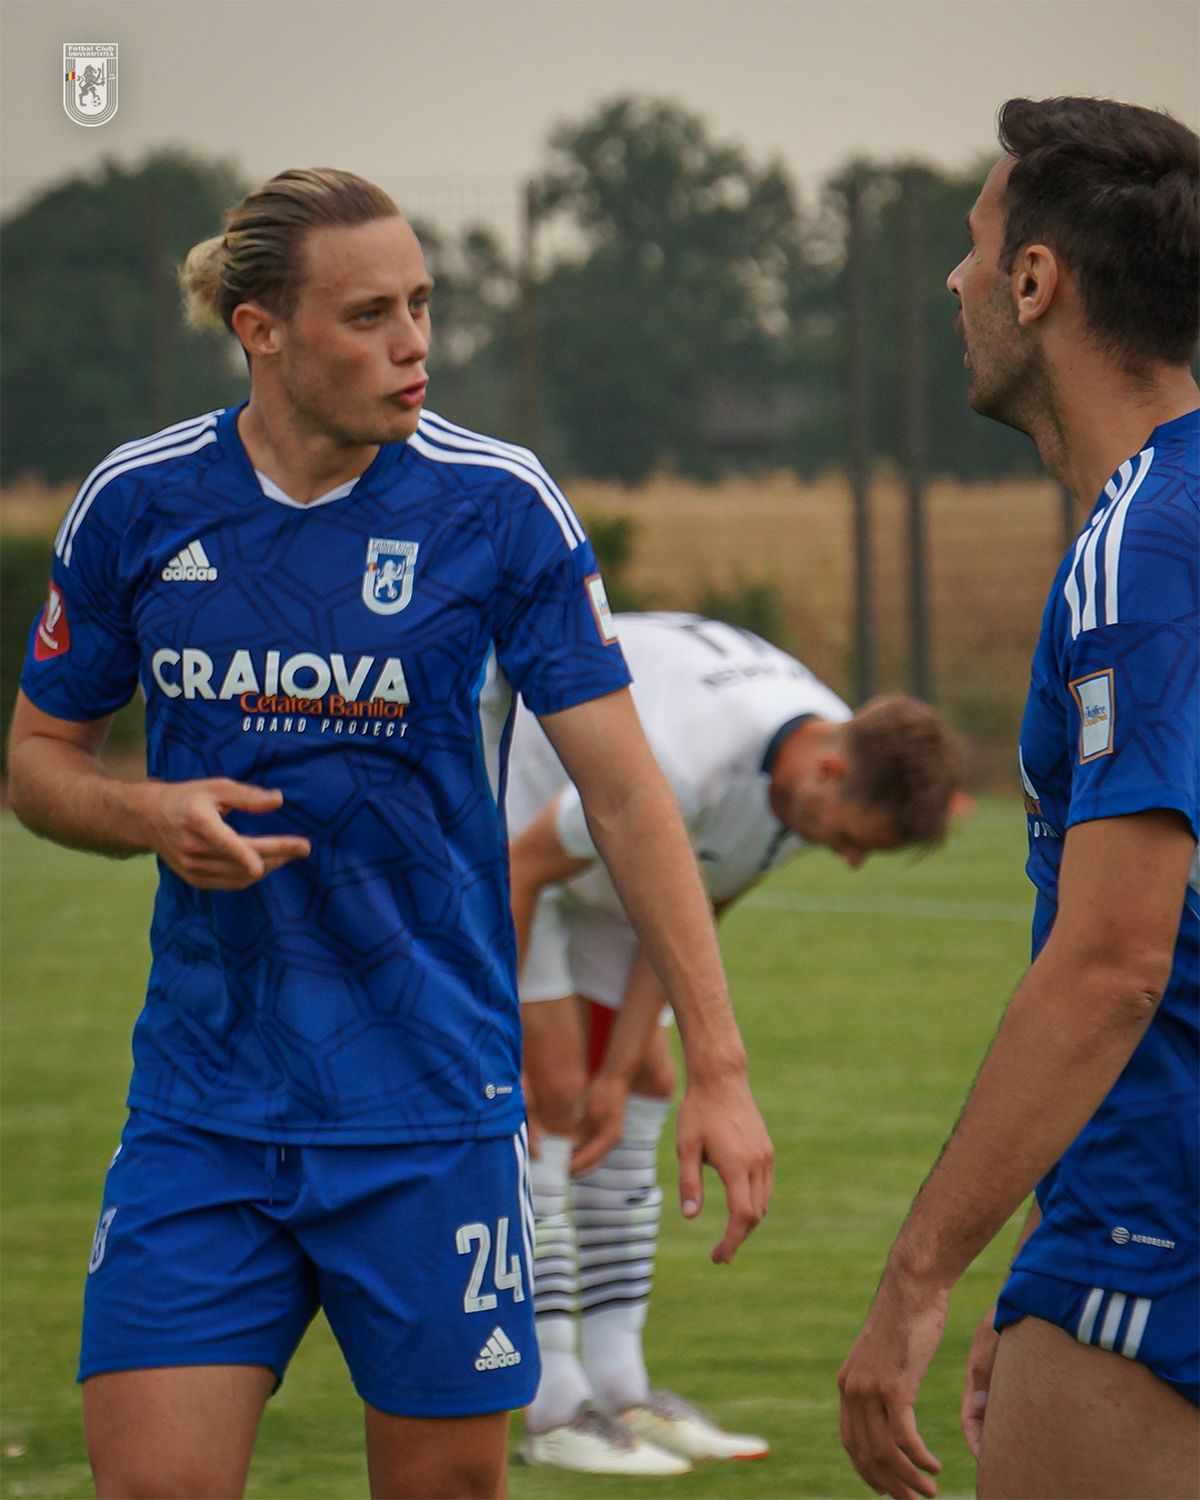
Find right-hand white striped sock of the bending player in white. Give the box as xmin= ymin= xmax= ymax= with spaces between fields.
xmin=572 ymin=1094 xmax=671 ymax=1412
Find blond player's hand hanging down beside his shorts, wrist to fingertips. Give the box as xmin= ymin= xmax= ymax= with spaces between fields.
xmin=675 ymin=1073 xmax=776 ymax=1265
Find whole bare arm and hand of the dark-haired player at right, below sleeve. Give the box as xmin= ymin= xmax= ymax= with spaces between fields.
xmin=839 ymin=812 xmax=1196 ymax=1500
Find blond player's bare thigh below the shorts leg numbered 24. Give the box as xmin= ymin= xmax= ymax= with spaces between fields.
xmin=366 ymin=1406 xmax=509 ymax=1500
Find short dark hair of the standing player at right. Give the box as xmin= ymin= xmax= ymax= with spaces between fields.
xmin=999 ymin=99 xmax=1200 ymax=374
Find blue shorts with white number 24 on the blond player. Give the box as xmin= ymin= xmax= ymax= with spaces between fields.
xmin=80 ymin=1110 xmax=539 ymax=1418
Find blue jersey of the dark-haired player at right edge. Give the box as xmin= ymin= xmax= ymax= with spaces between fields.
xmin=1017 ymin=414 xmax=1200 ymax=1293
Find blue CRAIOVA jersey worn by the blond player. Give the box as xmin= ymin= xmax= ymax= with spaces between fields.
xmin=21 ymin=408 xmax=629 ymax=1145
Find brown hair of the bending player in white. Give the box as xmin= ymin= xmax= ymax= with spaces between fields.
xmin=842 ymin=693 xmax=963 ymax=846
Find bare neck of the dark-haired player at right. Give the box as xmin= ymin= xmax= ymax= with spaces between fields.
xmin=1032 ymin=350 xmax=1200 ymax=515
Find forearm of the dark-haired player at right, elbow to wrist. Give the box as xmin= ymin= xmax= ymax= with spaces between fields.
xmin=887 ymin=938 xmax=1157 ymax=1290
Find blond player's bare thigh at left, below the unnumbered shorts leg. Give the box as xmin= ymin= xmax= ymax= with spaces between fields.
xmin=83 ymin=1365 xmax=275 ymax=1500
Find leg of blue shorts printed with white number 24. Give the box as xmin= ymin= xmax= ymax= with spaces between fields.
xmin=303 ymin=1127 xmax=539 ymax=1418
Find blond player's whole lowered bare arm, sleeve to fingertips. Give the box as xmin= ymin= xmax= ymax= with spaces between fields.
xmin=542 ymin=690 xmax=773 ymax=1262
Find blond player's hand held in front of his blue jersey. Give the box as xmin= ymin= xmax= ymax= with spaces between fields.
xmin=150 ymin=777 xmax=312 ymax=891
